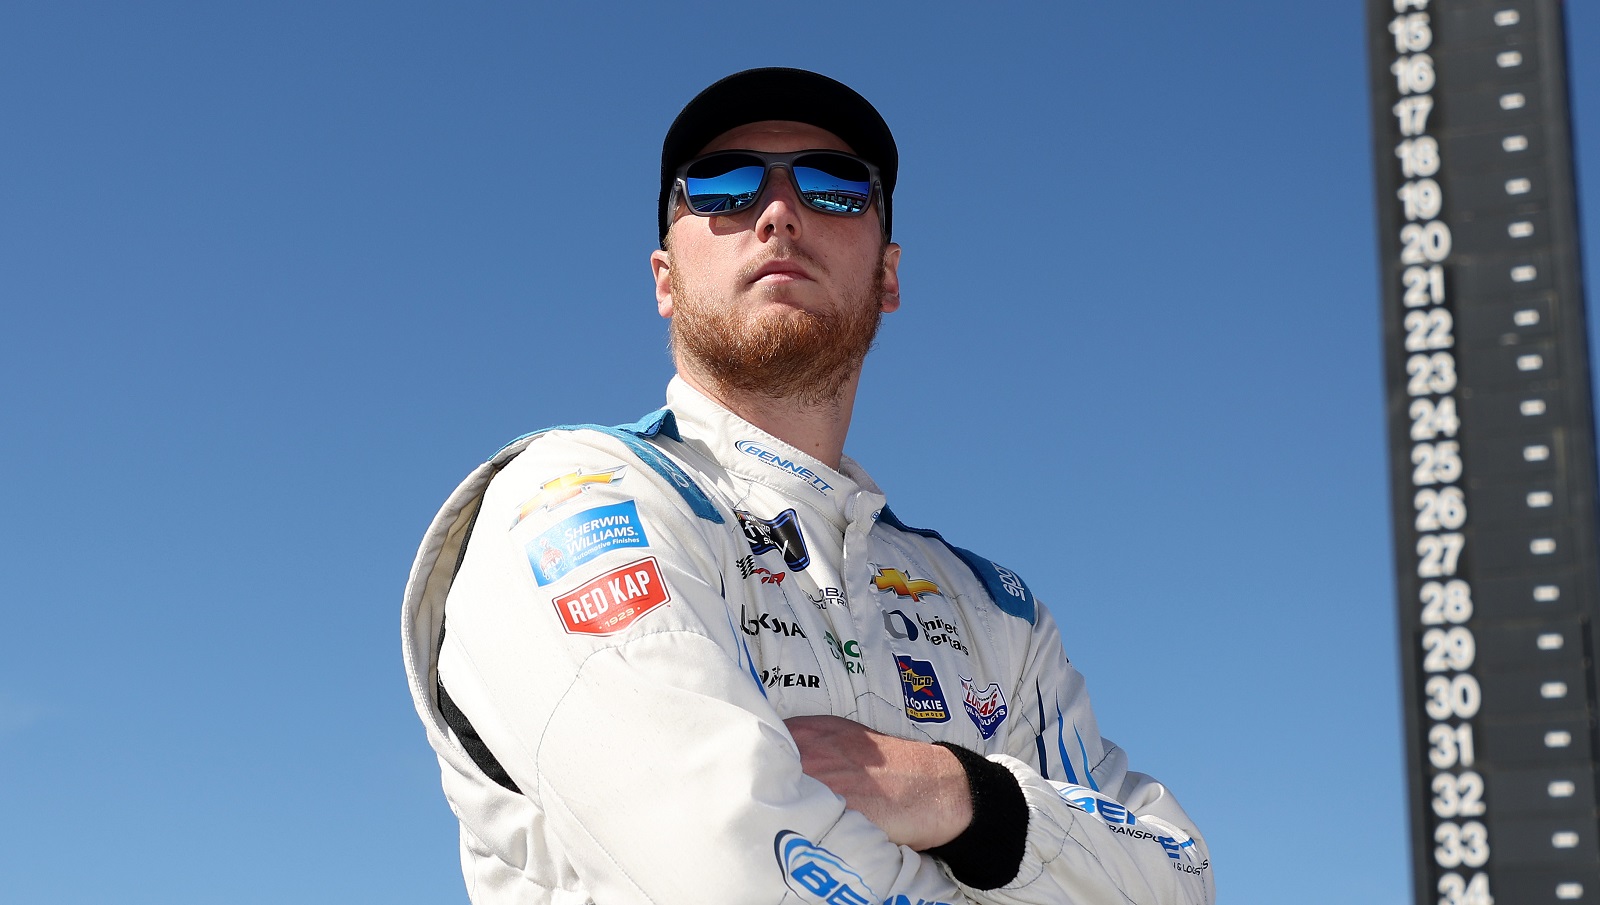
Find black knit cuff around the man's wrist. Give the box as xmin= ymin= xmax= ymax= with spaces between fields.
xmin=926 ymin=742 xmax=1027 ymax=889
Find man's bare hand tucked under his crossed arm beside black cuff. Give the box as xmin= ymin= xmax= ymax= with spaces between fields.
xmin=784 ymin=715 xmax=973 ymax=851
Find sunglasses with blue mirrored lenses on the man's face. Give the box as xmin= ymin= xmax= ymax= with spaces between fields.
xmin=674 ymin=150 xmax=880 ymax=217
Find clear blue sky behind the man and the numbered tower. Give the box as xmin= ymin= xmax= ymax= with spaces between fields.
xmin=0 ymin=0 xmax=1600 ymax=905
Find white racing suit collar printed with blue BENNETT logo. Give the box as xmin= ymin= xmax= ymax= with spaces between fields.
xmin=667 ymin=376 xmax=883 ymax=528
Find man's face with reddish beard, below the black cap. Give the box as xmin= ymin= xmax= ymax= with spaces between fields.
xmin=650 ymin=122 xmax=901 ymax=401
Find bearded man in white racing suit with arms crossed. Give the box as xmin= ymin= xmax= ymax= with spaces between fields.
xmin=403 ymin=69 xmax=1214 ymax=905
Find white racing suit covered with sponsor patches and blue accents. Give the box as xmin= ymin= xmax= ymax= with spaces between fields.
xmin=402 ymin=379 xmax=1214 ymax=905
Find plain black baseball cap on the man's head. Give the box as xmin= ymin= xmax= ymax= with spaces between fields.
xmin=656 ymin=67 xmax=899 ymax=246
